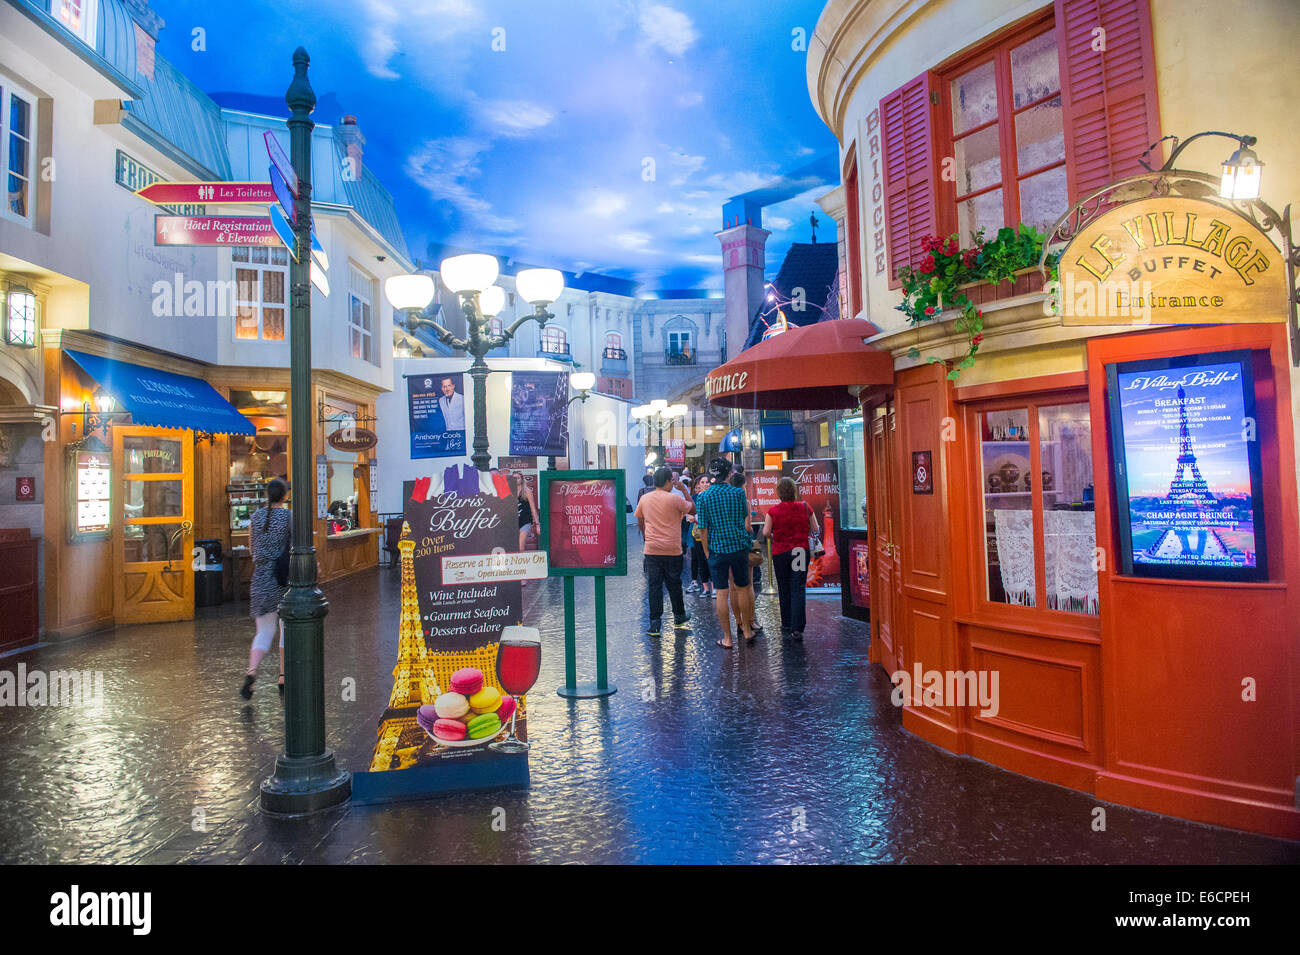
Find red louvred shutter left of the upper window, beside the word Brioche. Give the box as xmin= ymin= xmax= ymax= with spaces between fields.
xmin=880 ymin=73 xmax=939 ymax=288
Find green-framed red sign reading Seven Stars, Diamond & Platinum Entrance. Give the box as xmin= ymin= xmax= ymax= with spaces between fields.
xmin=541 ymin=470 xmax=628 ymax=577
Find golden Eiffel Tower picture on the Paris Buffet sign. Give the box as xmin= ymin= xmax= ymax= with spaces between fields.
xmin=371 ymin=522 xmax=442 ymax=773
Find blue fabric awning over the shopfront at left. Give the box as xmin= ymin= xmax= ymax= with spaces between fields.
xmin=66 ymin=348 xmax=257 ymax=434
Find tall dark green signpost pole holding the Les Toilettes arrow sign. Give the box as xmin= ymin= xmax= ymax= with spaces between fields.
xmin=261 ymin=47 xmax=352 ymax=815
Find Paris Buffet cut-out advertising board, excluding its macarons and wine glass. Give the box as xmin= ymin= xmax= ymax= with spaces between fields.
xmin=369 ymin=465 xmax=525 ymax=772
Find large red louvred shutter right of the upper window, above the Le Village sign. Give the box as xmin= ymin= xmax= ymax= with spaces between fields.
xmin=1054 ymin=0 xmax=1160 ymax=201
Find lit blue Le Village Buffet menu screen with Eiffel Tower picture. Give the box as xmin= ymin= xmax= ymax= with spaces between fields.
xmin=1106 ymin=351 xmax=1268 ymax=581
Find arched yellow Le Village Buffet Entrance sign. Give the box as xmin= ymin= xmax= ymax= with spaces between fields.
xmin=1053 ymin=196 xmax=1287 ymax=325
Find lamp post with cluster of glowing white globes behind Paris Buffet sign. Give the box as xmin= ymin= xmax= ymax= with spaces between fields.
xmin=384 ymin=259 xmax=564 ymax=470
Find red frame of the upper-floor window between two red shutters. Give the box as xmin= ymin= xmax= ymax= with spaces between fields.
xmin=935 ymin=6 xmax=1070 ymax=240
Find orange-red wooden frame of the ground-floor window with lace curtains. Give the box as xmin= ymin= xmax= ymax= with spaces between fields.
xmin=957 ymin=376 xmax=1105 ymax=639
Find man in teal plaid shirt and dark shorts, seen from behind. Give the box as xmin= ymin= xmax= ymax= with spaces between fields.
xmin=696 ymin=457 xmax=754 ymax=650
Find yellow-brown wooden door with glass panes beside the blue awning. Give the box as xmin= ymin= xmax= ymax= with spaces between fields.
xmin=113 ymin=426 xmax=194 ymax=624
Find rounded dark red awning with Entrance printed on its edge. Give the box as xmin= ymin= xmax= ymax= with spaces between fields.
xmin=705 ymin=318 xmax=893 ymax=411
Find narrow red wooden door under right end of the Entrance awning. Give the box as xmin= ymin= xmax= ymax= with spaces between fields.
xmin=867 ymin=399 xmax=901 ymax=673
